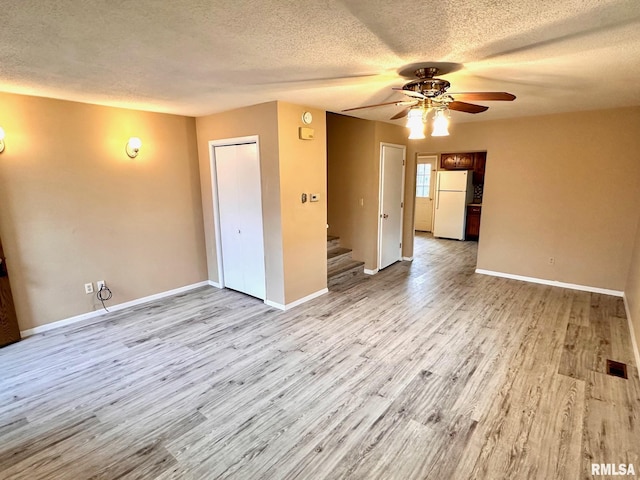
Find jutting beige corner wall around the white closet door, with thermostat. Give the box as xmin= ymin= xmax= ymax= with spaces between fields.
xmin=196 ymin=102 xmax=327 ymax=305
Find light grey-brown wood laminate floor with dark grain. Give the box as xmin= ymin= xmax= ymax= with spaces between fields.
xmin=0 ymin=235 xmax=640 ymax=480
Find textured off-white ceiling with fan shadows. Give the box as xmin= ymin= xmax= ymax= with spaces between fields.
xmin=0 ymin=0 xmax=640 ymax=121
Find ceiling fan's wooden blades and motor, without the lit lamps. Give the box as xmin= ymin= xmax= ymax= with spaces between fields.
xmin=342 ymin=67 xmax=516 ymax=120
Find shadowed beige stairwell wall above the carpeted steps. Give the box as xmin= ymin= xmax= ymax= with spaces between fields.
xmin=327 ymin=113 xmax=408 ymax=270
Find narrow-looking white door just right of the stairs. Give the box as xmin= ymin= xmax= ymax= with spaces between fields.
xmin=378 ymin=144 xmax=406 ymax=269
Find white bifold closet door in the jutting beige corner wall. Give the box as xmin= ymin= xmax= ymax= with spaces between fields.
xmin=214 ymin=143 xmax=266 ymax=300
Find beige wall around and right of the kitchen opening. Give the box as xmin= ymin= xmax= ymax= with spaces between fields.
xmin=405 ymin=104 xmax=640 ymax=290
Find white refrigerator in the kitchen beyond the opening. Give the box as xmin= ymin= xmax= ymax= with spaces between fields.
xmin=433 ymin=170 xmax=473 ymax=240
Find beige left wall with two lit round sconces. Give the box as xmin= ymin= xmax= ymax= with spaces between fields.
xmin=0 ymin=94 xmax=206 ymax=330
